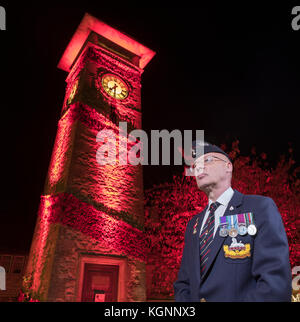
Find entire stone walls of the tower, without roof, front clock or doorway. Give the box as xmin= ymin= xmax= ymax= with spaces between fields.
xmin=26 ymin=44 xmax=146 ymax=301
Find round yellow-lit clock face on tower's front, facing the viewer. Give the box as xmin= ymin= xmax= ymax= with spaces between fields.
xmin=101 ymin=74 xmax=128 ymax=100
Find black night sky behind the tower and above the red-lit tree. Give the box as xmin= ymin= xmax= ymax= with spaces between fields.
xmin=0 ymin=1 xmax=300 ymax=251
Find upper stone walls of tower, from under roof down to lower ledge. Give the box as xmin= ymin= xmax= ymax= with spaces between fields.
xmin=45 ymin=46 xmax=143 ymax=225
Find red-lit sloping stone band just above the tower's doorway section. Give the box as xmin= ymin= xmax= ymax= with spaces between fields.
xmin=36 ymin=193 xmax=145 ymax=260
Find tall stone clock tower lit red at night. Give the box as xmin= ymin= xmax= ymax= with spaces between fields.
xmin=23 ymin=14 xmax=155 ymax=301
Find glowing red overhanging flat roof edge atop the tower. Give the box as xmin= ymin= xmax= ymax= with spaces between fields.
xmin=58 ymin=13 xmax=155 ymax=72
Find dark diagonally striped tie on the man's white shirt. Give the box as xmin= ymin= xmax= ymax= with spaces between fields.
xmin=200 ymin=202 xmax=220 ymax=275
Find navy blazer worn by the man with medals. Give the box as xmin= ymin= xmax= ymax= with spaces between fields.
xmin=174 ymin=190 xmax=292 ymax=302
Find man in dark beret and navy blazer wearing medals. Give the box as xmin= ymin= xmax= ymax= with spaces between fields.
xmin=174 ymin=141 xmax=291 ymax=302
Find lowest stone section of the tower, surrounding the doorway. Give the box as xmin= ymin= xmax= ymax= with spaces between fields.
xmin=48 ymin=226 xmax=146 ymax=302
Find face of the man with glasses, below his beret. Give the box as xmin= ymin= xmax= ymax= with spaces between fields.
xmin=193 ymin=152 xmax=232 ymax=190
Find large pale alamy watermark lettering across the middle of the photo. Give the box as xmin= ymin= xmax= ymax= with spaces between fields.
xmin=96 ymin=122 xmax=204 ymax=176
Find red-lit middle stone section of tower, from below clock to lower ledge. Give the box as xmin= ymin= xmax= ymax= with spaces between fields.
xmin=50 ymin=103 xmax=143 ymax=221
